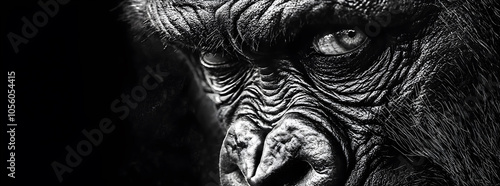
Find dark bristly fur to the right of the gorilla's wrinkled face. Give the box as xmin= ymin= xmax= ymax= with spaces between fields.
xmin=383 ymin=0 xmax=500 ymax=185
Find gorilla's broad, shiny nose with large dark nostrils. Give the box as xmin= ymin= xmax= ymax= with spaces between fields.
xmin=219 ymin=116 xmax=346 ymax=186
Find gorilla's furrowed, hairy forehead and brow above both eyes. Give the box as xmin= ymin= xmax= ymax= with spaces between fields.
xmin=142 ymin=0 xmax=430 ymax=49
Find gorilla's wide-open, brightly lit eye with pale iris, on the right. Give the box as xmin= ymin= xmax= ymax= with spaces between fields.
xmin=313 ymin=28 xmax=368 ymax=55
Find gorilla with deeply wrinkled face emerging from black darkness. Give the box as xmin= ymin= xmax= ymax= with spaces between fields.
xmin=124 ymin=0 xmax=500 ymax=186
